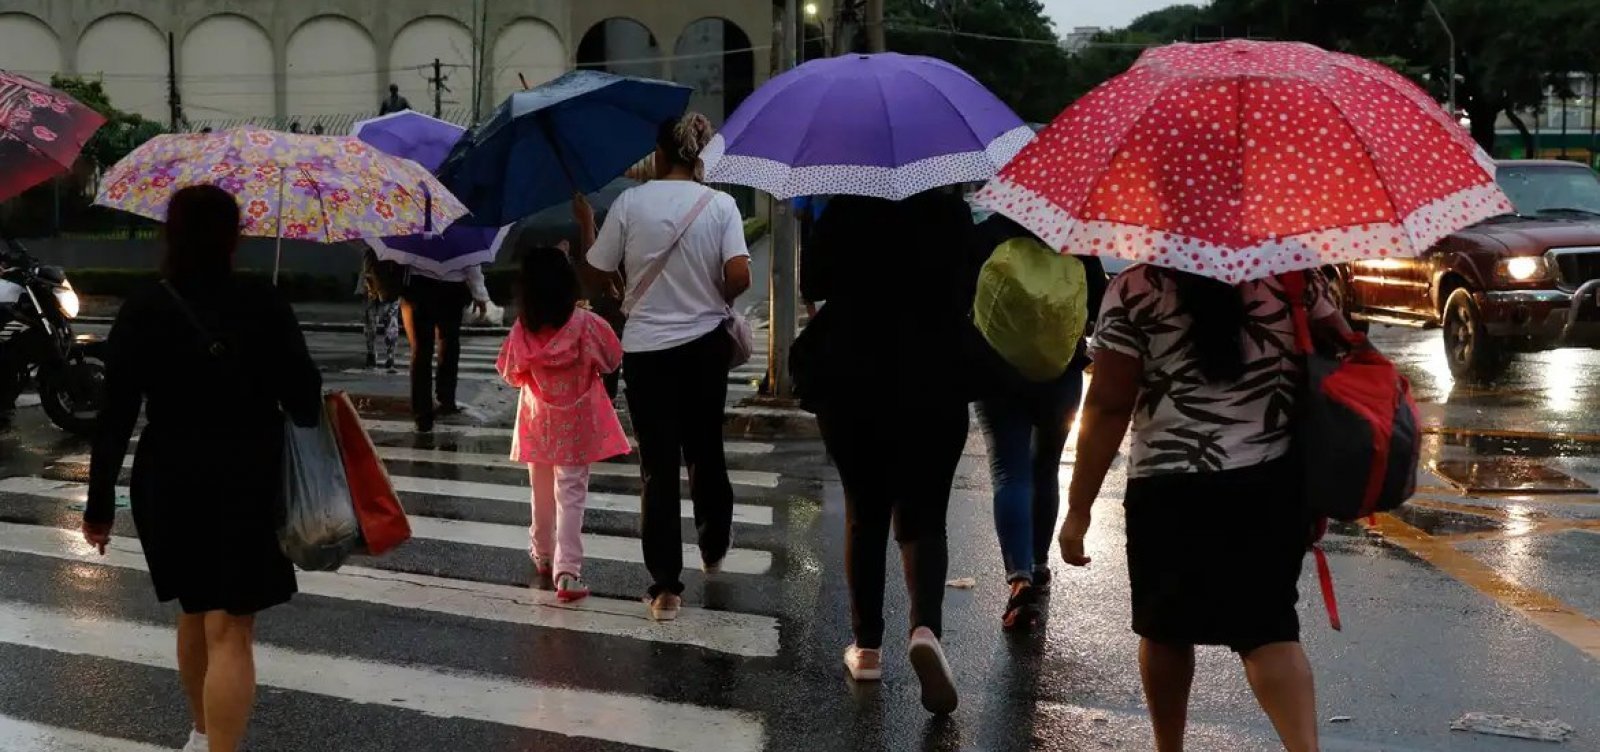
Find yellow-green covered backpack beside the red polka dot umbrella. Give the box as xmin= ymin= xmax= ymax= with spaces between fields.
xmin=973 ymin=237 xmax=1088 ymax=382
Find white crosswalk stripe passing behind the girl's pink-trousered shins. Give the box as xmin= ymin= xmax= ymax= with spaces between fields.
xmin=0 ymin=478 xmax=773 ymax=574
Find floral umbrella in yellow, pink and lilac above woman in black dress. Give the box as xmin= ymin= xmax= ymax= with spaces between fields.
xmin=94 ymin=128 xmax=467 ymax=277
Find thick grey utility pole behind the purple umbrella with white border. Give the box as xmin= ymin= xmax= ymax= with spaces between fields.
xmin=766 ymin=0 xmax=800 ymax=400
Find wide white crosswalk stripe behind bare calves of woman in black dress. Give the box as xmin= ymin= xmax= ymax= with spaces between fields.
xmin=0 ymin=602 xmax=765 ymax=752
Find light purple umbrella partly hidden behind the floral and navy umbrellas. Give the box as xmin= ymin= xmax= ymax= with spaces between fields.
xmin=350 ymin=110 xmax=510 ymax=275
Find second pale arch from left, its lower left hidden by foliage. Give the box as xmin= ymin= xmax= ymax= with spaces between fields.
xmin=77 ymin=13 xmax=171 ymax=123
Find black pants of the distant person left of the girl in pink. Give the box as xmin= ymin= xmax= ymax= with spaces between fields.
xmin=400 ymin=275 xmax=472 ymax=421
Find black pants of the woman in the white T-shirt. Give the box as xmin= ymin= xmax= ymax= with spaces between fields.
xmin=622 ymin=328 xmax=733 ymax=597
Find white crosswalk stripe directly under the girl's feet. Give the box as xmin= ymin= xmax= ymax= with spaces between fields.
xmin=0 ymin=522 xmax=778 ymax=659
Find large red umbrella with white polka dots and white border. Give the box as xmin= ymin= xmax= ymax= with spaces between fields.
xmin=978 ymin=40 xmax=1512 ymax=282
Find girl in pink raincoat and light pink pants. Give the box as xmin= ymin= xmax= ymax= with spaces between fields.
xmin=496 ymin=248 xmax=629 ymax=602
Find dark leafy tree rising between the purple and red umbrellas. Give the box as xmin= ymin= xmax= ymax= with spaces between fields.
xmin=885 ymin=0 xmax=1074 ymax=123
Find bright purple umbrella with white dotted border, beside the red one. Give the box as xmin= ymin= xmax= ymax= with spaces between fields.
xmin=702 ymin=53 xmax=1034 ymax=200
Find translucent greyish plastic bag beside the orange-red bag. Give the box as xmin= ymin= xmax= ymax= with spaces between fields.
xmin=278 ymin=410 xmax=362 ymax=571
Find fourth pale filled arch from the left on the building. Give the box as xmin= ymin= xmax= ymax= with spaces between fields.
xmin=285 ymin=16 xmax=381 ymax=122
